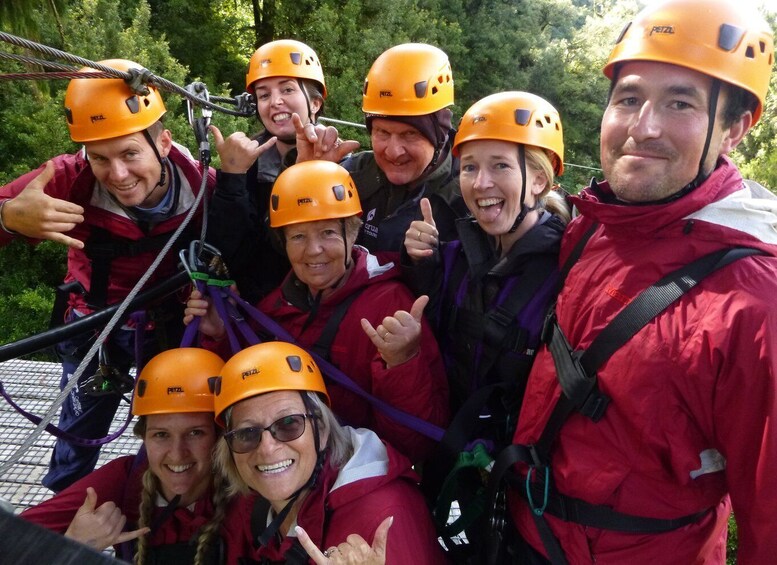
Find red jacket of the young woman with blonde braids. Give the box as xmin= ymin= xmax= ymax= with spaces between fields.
xmin=21 ymin=455 xmax=224 ymax=552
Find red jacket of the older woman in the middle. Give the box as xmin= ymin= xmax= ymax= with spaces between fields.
xmin=209 ymin=246 xmax=449 ymax=461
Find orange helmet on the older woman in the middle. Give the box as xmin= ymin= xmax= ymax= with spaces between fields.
xmin=270 ymin=161 xmax=362 ymax=228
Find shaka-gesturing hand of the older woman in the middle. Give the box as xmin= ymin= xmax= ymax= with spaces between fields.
xmin=361 ymin=295 xmax=429 ymax=368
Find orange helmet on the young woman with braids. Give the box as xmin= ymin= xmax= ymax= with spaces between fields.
xmin=132 ymin=347 xmax=224 ymax=416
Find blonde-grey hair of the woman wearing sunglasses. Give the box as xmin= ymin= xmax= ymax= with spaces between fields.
xmin=214 ymin=391 xmax=353 ymax=496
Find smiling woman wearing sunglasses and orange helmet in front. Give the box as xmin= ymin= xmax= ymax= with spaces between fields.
xmin=214 ymin=342 xmax=445 ymax=564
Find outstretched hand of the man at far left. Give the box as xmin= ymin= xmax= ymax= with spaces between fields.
xmin=2 ymin=161 xmax=84 ymax=249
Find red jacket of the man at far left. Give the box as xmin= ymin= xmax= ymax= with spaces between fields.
xmin=0 ymin=145 xmax=216 ymax=313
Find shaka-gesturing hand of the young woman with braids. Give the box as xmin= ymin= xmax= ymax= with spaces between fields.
xmin=65 ymin=487 xmax=150 ymax=551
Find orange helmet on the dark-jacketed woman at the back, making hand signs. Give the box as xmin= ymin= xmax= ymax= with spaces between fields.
xmin=246 ymin=39 xmax=326 ymax=98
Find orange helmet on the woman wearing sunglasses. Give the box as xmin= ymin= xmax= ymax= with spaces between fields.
xmin=214 ymin=341 xmax=329 ymax=426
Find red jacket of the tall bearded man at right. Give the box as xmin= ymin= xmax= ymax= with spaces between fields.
xmin=511 ymin=158 xmax=777 ymax=565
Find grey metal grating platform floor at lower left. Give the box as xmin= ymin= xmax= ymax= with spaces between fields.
xmin=0 ymin=359 xmax=140 ymax=513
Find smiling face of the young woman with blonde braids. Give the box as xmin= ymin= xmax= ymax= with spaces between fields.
xmin=143 ymin=412 xmax=216 ymax=506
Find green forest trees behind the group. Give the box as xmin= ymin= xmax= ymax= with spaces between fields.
xmin=0 ymin=0 xmax=777 ymax=348
